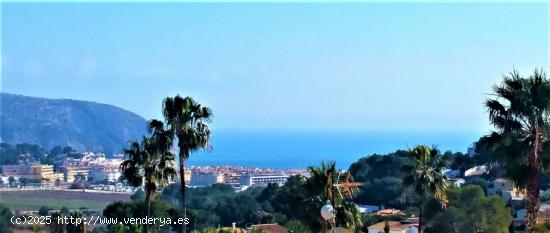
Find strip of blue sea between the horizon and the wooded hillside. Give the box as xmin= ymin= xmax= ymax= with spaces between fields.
xmin=187 ymin=130 xmax=483 ymax=169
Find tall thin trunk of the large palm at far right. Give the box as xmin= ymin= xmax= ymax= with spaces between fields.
xmin=525 ymin=127 xmax=542 ymax=232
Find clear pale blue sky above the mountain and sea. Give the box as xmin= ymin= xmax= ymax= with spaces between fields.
xmin=1 ymin=3 xmax=549 ymax=131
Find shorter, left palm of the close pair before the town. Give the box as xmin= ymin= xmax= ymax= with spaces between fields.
xmin=121 ymin=120 xmax=177 ymax=233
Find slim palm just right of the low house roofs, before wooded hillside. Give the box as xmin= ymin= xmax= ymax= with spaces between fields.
xmin=403 ymin=146 xmax=448 ymax=233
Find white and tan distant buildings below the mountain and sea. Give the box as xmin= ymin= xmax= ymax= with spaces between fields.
xmin=0 ymin=152 xmax=309 ymax=191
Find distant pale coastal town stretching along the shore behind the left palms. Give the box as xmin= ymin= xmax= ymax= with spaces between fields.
xmin=0 ymin=152 xmax=308 ymax=193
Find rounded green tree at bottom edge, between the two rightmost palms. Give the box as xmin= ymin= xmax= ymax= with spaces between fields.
xmin=426 ymin=185 xmax=513 ymax=233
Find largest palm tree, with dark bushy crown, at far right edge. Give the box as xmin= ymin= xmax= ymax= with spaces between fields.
xmin=480 ymin=70 xmax=550 ymax=232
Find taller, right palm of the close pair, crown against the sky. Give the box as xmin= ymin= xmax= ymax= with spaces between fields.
xmin=162 ymin=95 xmax=212 ymax=233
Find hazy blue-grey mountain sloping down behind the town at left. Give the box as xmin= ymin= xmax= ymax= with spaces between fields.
xmin=0 ymin=93 xmax=147 ymax=154
